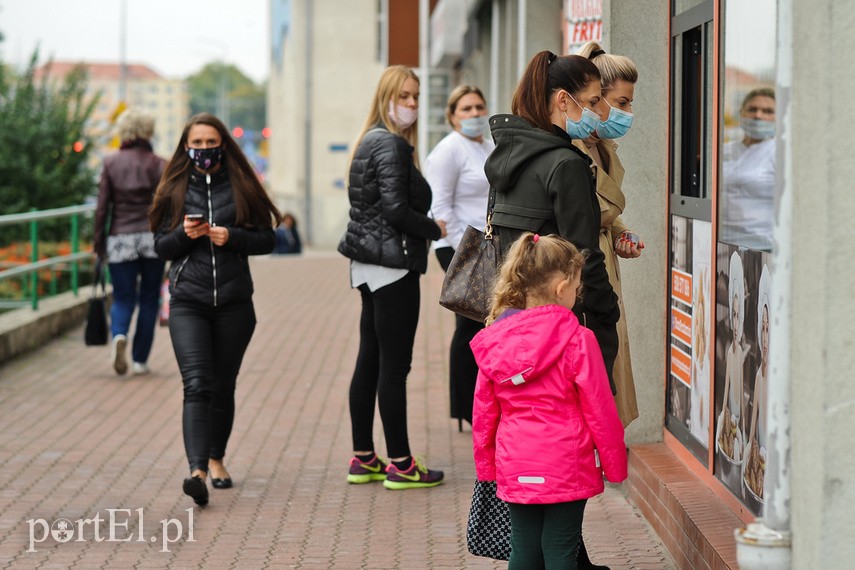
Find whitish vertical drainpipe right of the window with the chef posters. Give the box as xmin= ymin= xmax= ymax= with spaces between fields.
xmin=734 ymin=0 xmax=793 ymax=570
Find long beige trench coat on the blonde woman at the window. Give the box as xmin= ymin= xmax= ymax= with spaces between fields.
xmin=573 ymin=140 xmax=638 ymax=427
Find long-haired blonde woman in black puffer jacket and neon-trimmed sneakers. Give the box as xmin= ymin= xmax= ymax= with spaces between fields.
xmin=338 ymin=65 xmax=445 ymax=489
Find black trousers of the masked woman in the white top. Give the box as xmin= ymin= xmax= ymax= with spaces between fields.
xmin=436 ymin=247 xmax=484 ymax=424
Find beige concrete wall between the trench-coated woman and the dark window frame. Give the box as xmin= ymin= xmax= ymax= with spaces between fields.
xmin=603 ymin=2 xmax=669 ymax=443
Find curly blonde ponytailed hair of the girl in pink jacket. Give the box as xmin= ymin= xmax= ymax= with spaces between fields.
xmin=486 ymin=232 xmax=585 ymax=325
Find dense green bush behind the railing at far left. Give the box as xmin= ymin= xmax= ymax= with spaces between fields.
xmin=0 ymin=51 xmax=97 ymax=240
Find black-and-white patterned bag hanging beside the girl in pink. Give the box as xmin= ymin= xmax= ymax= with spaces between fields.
xmin=466 ymin=481 xmax=511 ymax=560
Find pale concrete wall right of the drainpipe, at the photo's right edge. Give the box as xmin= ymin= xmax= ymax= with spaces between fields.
xmin=788 ymin=0 xmax=855 ymax=568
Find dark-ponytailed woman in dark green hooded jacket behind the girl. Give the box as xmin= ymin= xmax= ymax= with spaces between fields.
xmin=484 ymin=51 xmax=620 ymax=568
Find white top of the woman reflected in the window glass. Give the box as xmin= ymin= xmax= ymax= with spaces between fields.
xmin=718 ymin=138 xmax=775 ymax=250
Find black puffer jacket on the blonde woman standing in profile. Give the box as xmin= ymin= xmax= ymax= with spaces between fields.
xmin=338 ymin=127 xmax=441 ymax=273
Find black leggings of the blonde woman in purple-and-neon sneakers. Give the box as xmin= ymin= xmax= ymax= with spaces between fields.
xmin=350 ymin=271 xmax=419 ymax=457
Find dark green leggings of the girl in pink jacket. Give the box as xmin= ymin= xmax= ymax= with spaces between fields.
xmin=508 ymin=499 xmax=587 ymax=570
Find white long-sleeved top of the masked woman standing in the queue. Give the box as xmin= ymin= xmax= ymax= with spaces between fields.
xmin=425 ymin=131 xmax=495 ymax=249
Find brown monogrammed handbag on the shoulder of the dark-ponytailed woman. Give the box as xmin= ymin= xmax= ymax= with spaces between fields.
xmin=439 ymin=189 xmax=501 ymax=323
